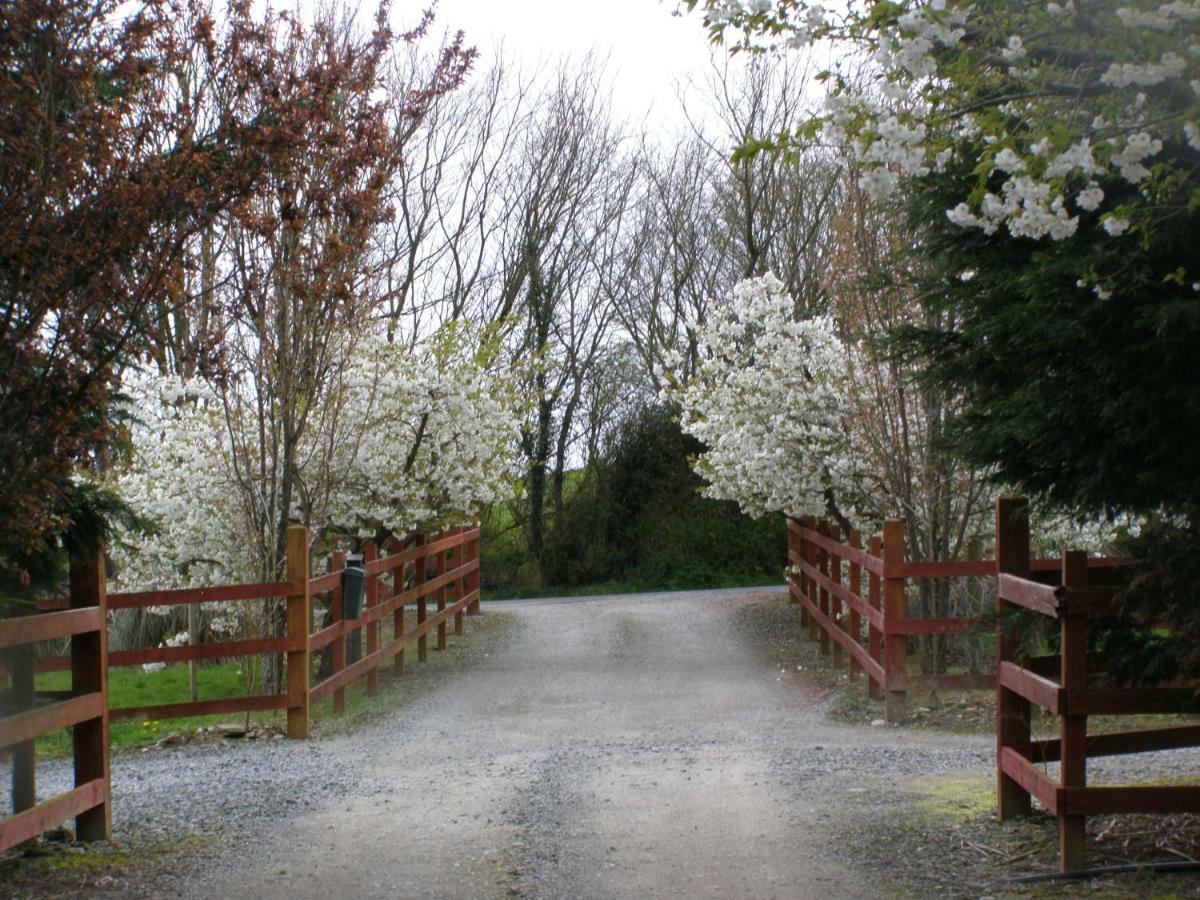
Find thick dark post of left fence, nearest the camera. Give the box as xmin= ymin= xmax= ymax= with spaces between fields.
xmin=70 ymin=548 xmax=113 ymax=841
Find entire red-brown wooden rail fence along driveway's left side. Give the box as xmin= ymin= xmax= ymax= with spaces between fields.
xmin=0 ymin=526 xmax=479 ymax=852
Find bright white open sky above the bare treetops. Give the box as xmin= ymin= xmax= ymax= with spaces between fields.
xmin=429 ymin=0 xmax=722 ymax=130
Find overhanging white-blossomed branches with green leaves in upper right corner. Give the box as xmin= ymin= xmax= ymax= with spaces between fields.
xmin=685 ymin=0 xmax=1200 ymax=299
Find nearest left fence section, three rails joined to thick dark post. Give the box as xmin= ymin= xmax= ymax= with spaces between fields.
xmin=0 ymin=554 xmax=112 ymax=852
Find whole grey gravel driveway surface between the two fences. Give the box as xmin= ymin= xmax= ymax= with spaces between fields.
xmin=0 ymin=589 xmax=1200 ymax=898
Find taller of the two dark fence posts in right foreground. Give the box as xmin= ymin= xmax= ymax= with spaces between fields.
xmin=996 ymin=497 xmax=1031 ymax=820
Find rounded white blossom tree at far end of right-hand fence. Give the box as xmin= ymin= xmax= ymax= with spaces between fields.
xmin=664 ymin=275 xmax=852 ymax=518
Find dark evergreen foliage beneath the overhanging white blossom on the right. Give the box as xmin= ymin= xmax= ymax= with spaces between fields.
xmin=898 ymin=146 xmax=1200 ymax=680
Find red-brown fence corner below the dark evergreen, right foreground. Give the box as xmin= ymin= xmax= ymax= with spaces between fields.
xmin=996 ymin=499 xmax=1200 ymax=871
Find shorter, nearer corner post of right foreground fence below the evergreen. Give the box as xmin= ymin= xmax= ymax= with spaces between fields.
xmin=1058 ymin=551 xmax=1087 ymax=872
